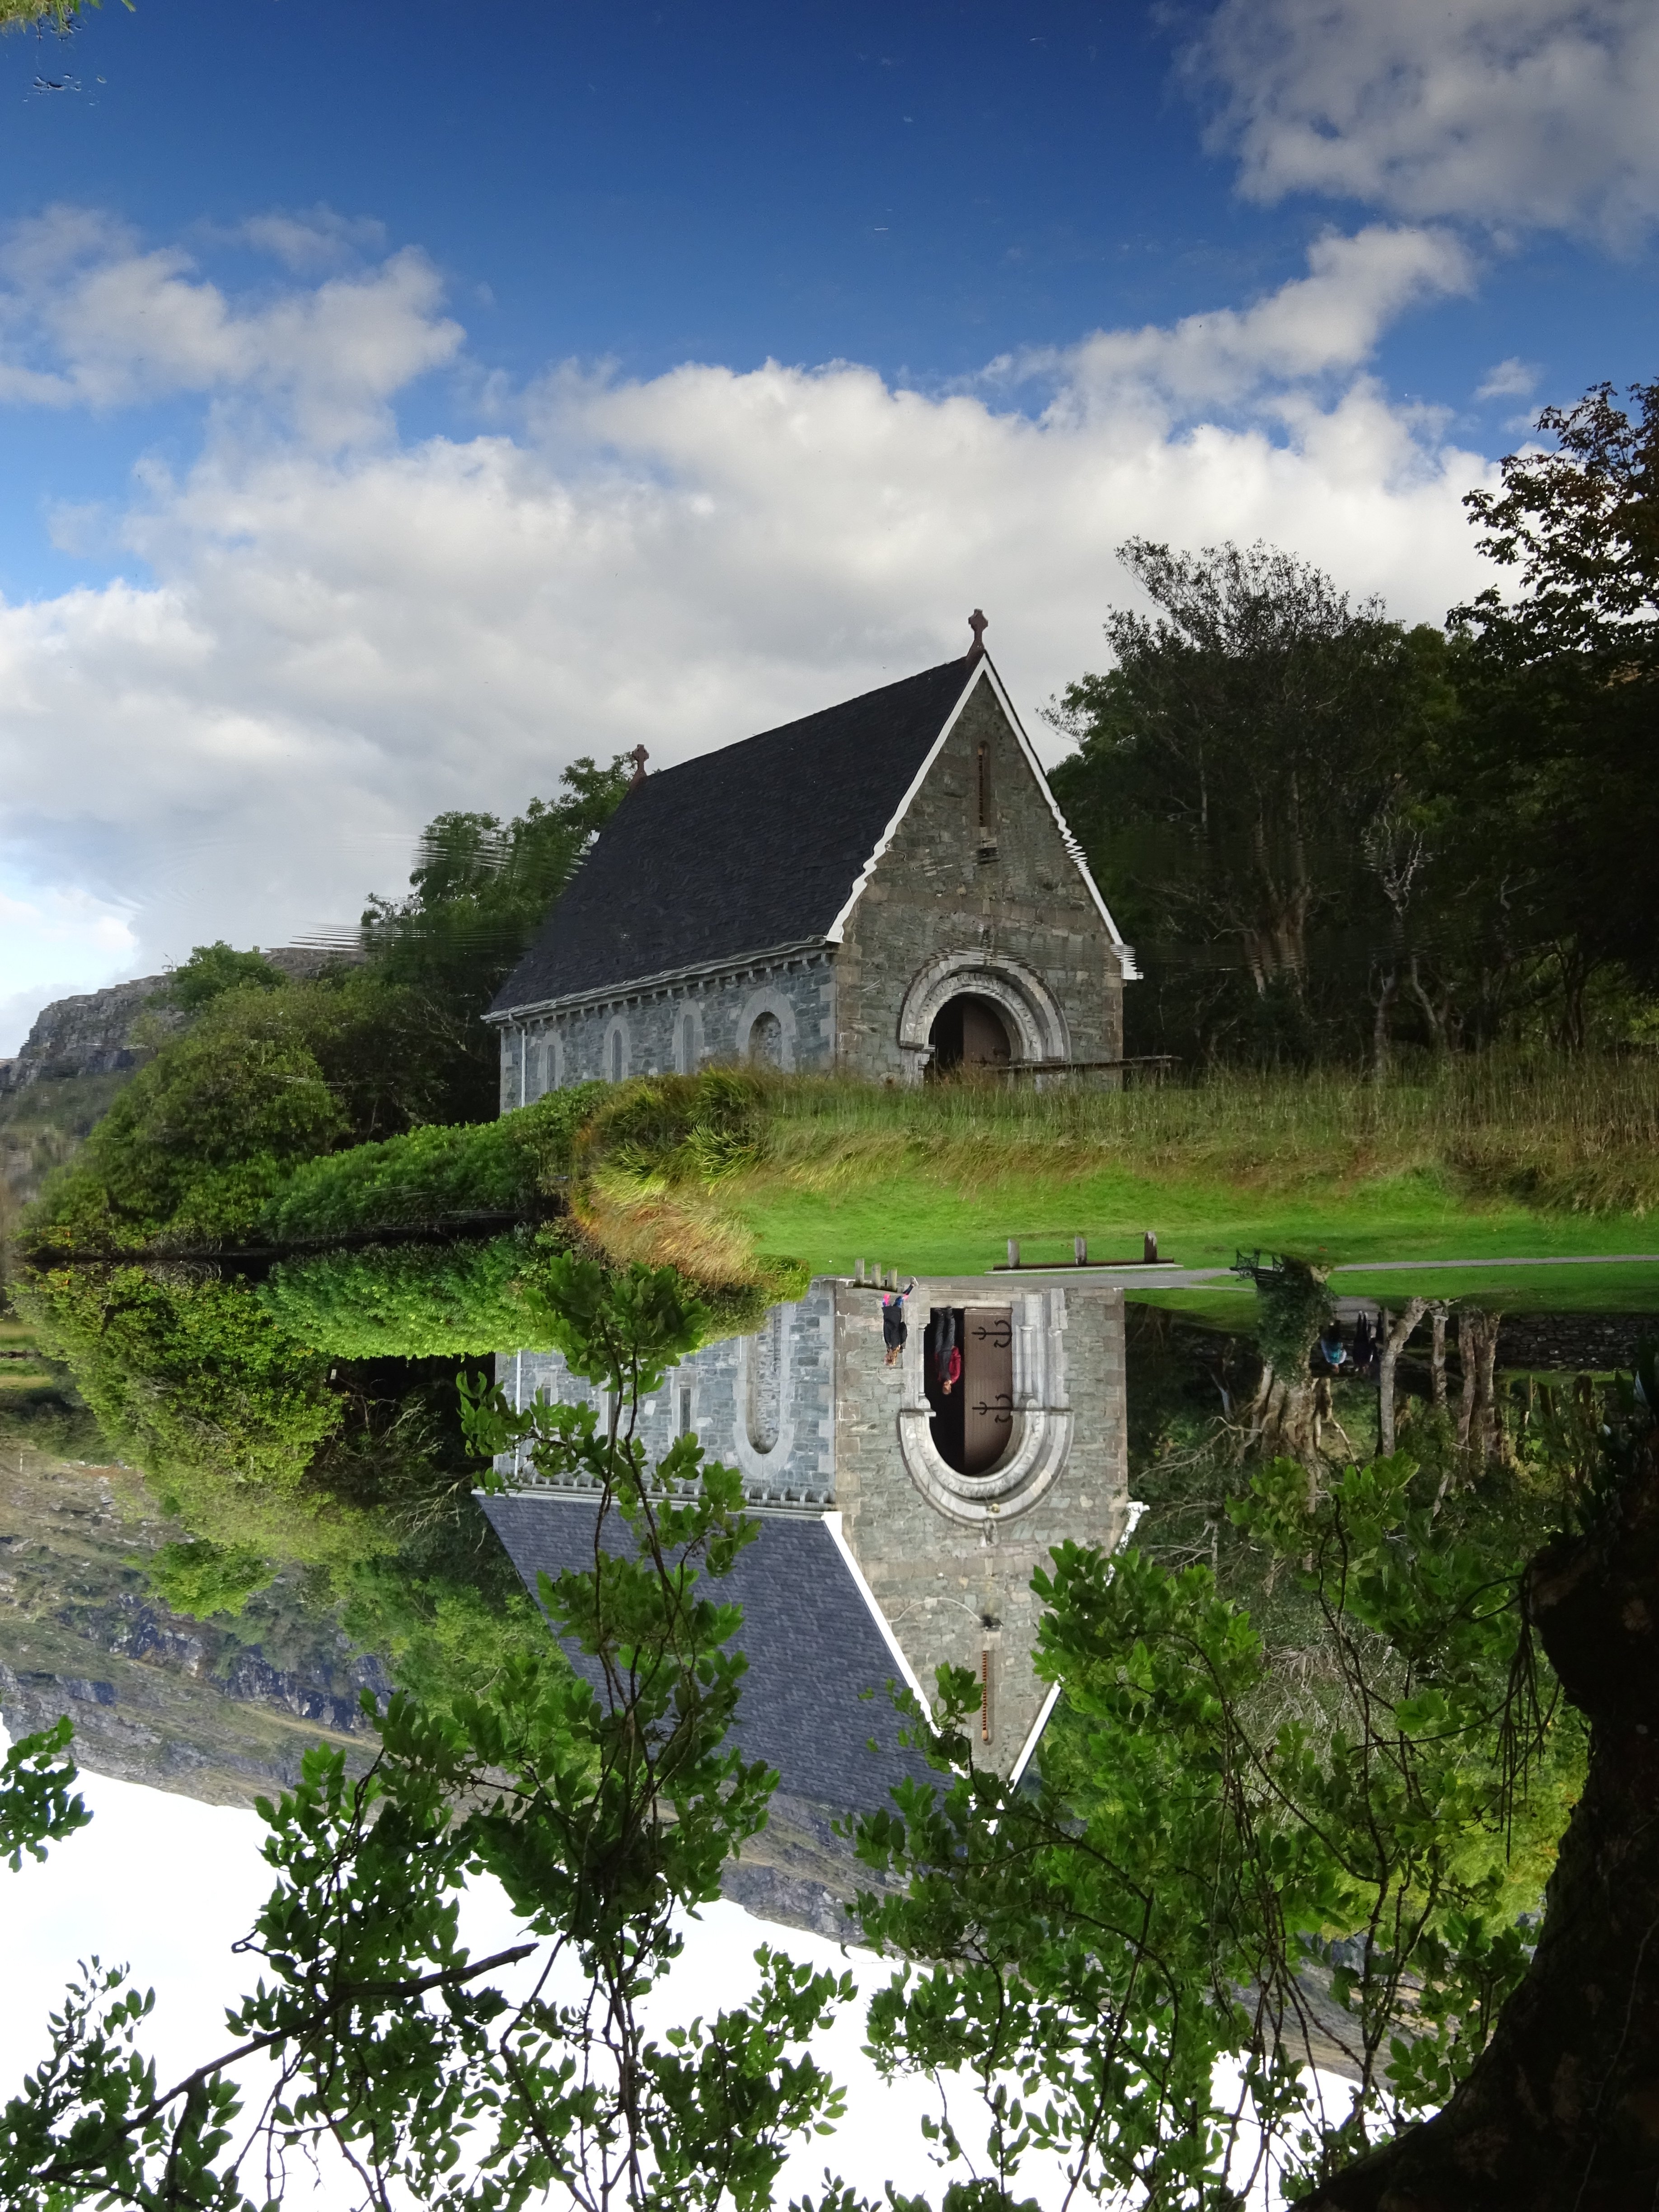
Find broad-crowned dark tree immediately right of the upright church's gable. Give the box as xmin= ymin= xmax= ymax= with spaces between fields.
xmin=1053 ymin=538 xmax=1449 ymax=1059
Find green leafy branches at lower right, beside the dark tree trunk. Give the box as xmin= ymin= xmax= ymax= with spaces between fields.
xmin=849 ymin=1456 xmax=1584 ymax=2212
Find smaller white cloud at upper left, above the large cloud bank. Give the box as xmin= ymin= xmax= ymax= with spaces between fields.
xmin=0 ymin=208 xmax=462 ymax=445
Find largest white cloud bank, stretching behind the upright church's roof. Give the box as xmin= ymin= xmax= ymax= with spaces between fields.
xmin=0 ymin=216 xmax=1489 ymax=1044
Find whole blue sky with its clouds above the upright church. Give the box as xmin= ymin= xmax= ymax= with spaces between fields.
xmin=0 ymin=0 xmax=1659 ymax=1051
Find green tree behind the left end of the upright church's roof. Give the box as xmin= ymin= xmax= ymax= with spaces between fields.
xmin=363 ymin=756 xmax=633 ymax=1121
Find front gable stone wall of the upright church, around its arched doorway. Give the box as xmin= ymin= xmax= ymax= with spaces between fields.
xmin=836 ymin=684 xmax=1124 ymax=1082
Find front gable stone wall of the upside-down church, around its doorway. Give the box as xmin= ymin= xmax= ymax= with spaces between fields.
xmin=836 ymin=1283 xmax=1128 ymax=1774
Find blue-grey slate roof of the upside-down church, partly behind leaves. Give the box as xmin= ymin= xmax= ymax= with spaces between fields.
xmin=480 ymin=1493 xmax=938 ymax=1812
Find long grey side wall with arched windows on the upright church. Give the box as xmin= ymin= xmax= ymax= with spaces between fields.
xmin=491 ymin=953 xmax=836 ymax=1113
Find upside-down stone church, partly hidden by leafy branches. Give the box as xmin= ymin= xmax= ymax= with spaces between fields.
xmin=482 ymin=1276 xmax=1128 ymax=1903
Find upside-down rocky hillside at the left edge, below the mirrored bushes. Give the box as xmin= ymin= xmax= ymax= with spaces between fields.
xmin=0 ymin=1449 xmax=387 ymax=1805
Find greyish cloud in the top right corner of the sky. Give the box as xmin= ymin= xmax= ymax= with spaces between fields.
xmin=1188 ymin=0 xmax=1659 ymax=244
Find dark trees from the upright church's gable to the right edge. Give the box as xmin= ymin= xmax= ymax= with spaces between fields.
xmin=1051 ymin=413 xmax=1659 ymax=1075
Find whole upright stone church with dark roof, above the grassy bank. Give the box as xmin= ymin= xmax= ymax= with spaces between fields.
xmin=489 ymin=619 xmax=1135 ymax=1108
